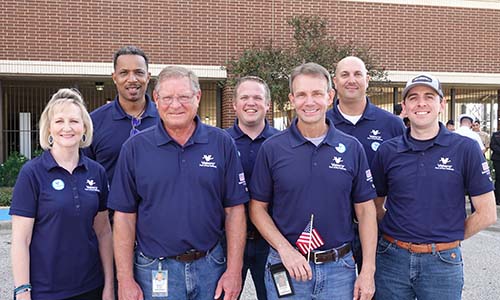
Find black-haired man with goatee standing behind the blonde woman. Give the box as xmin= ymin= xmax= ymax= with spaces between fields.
xmin=84 ymin=46 xmax=158 ymax=184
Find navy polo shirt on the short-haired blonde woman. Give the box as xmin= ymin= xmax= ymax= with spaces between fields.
xmin=10 ymin=151 xmax=108 ymax=300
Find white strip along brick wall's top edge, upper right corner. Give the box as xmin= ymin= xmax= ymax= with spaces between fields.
xmin=344 ymin=0 xmax=500 ymax=9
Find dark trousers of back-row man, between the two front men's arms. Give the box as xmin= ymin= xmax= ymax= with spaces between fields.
xmin=241 ymin=237 xmax=269 ymax=300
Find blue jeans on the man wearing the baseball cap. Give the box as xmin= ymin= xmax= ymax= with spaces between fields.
xmin=375 ymin=238 xmax=464 ymax=300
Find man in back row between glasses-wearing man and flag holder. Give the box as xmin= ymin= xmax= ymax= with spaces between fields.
xmin=226 ymin=76 xmax=279 ymax=300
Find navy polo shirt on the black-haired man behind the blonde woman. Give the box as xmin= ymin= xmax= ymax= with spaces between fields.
xmin=83 ymin=95 xmax=159 ymax=183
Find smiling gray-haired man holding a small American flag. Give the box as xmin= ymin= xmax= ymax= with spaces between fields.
xmin=250 ymin=63 xmax=377 ymax=300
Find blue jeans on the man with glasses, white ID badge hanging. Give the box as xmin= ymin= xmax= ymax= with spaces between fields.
xmin=134 ymin=244 xmax=226 ymax=300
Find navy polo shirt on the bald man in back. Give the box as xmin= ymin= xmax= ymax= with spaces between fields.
xmin=326 ymin=97 xmax=405 ymax=163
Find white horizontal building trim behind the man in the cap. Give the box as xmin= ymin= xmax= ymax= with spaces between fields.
xmin=387 ymin=71 xmax=500 ymax=87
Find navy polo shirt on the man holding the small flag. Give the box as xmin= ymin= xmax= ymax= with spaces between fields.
xmin=250 ymin=119 xmax=375 ymax=249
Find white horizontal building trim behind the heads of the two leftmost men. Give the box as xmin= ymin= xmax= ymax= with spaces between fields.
xmin=0 ymin=60 xmax=227 ymax=80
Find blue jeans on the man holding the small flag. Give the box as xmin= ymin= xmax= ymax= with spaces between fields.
xmin=265 ymin=248 xmax=356 ymax=300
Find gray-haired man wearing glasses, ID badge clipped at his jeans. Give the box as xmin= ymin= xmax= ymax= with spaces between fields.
xmin=108 ymin=67 xmax=248 ymax=300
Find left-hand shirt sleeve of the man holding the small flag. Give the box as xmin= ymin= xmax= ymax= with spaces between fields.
xmin=250 ymin=142 xmax=274 ymax=202
